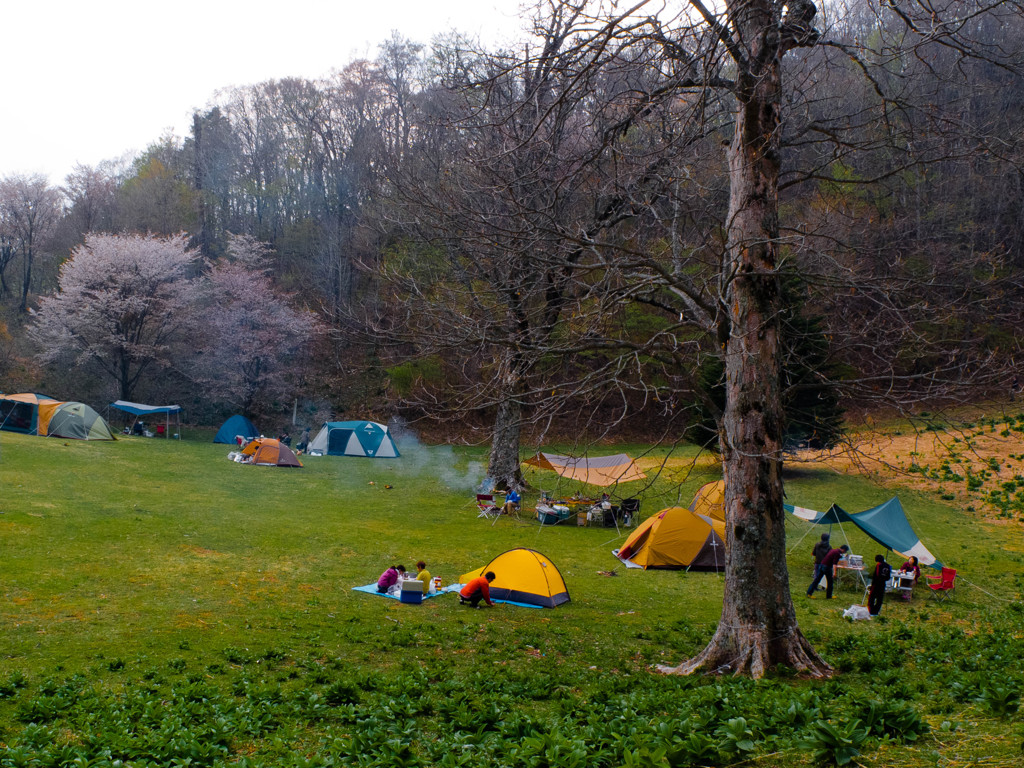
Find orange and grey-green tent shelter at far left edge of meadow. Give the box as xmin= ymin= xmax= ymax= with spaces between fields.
xmin=0 ymin=392 xmax=114 ymax=440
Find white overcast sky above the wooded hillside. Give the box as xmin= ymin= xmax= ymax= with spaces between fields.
xmin=0 ymin=0 xmax=521 ymax=184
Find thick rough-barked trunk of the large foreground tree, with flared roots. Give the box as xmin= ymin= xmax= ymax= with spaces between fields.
xmin=660 ymin=1 xmax=831 ymax=678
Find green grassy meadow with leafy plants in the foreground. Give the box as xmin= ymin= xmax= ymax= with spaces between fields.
xmin=0 ymin=433 xmax=1024 ymax=768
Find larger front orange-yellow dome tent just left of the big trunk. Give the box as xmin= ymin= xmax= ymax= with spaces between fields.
xmin=612 ymin=507 xmax=725 ymax=570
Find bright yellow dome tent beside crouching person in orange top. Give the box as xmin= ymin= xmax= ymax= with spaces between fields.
xmin=459 ymin=547 xmax=569 ymax=608
